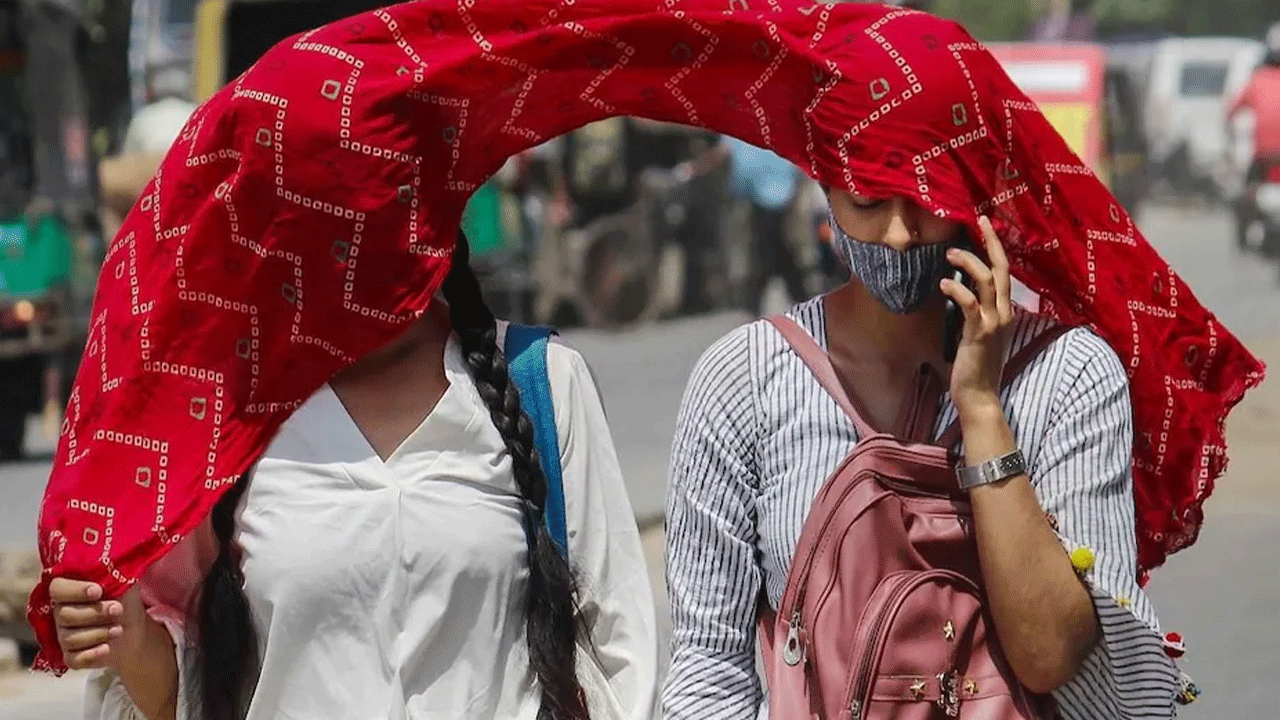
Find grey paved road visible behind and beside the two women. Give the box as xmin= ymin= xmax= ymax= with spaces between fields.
xmin=0 ymin=204 xmax=1280 ymax=720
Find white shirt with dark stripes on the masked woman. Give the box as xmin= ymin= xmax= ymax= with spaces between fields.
xmin=662 ymin=299 xmax=1179 ymax=720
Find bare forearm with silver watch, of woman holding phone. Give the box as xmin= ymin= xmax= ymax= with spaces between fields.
xmin=960 ymin=398 xmax=1098 ymax=692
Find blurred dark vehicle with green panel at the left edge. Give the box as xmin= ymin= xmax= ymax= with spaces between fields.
xmin=0 ymin=0 xmax=122 ymax=460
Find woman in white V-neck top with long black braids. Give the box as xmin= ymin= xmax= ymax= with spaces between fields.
xmin=52 ymin=230 xmax=657 ymax=720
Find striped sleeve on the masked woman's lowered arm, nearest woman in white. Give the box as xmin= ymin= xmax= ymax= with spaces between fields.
xmin=662 ymin=327 xmax=763 ymax=720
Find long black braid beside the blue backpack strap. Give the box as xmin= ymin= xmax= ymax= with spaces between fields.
xmin=444 ymin=233 xmax=588 ymax=720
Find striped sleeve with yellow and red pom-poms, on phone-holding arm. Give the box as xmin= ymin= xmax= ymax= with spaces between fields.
xmin=1030 ymin=329 xmax=1179 ymax=720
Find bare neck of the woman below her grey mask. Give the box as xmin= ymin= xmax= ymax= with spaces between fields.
xmin=826 ymin=279 xmax=946 ymax=370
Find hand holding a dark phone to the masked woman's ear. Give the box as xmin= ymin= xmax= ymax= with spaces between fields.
xmin=942 ymin=217 xmax=1014 ymax=418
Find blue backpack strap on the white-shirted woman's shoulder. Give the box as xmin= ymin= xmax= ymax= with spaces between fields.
xmin=503 ymin=323 xmax=568 ymax=557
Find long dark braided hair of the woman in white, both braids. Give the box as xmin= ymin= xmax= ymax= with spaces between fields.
xmin=197 ymin=233 xmax=589 ymax=720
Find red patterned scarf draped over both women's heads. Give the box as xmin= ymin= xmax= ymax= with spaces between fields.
xmin=29 ymin=0 xmax=1262 ymax=669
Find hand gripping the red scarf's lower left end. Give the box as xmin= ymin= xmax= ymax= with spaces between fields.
xmin=49 ymin=578 xmax=155 ymax=670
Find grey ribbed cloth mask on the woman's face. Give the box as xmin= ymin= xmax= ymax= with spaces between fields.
xmin=828 ymin=208 xmax=951 ymax=314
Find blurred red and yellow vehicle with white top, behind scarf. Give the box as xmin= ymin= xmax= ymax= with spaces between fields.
xmin=988 ymin=42 xmax=1149 ymax=214
